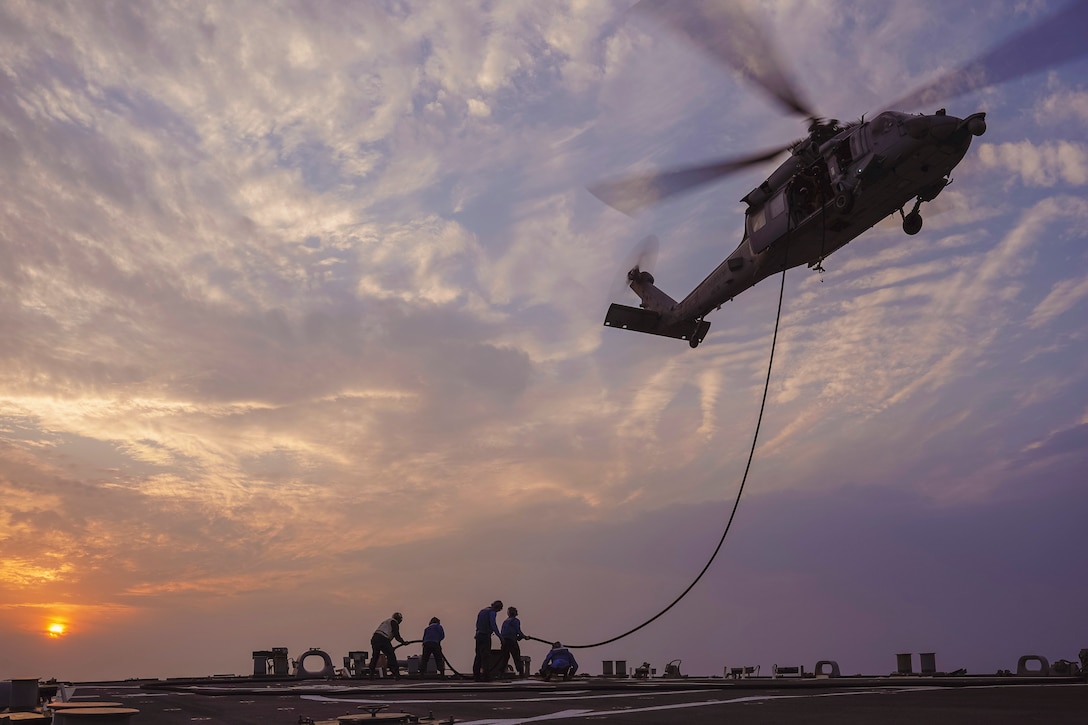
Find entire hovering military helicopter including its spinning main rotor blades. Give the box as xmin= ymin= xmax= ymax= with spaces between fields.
xmin=589 ymin=0 xmax=1088 ymax=348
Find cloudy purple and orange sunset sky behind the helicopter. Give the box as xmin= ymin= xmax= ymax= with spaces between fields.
xmin=0 ymin=0 xmax=1088 ymax=680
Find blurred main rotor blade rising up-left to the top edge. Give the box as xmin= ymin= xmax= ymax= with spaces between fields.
xmin=631 ymin=0 xmax=816 ymax=118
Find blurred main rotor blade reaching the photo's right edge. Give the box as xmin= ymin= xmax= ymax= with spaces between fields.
xmin=888 ymin=0 xmax=1088 ymax=111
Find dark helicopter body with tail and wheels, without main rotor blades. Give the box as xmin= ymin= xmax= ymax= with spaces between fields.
xmin=605 ymin=110 xmax=986 ymax=347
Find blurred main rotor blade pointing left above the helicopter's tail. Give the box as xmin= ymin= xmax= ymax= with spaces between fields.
xmin=590 ymin=146 xmax=790 ymax=216
